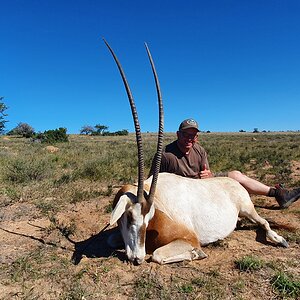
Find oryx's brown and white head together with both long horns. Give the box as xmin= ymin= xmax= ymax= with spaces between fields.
xmin=104 ymin=40 xmax=164 ymax=264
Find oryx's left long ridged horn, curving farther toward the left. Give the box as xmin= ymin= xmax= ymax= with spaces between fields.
xmin=103 ymin=39 xmax=144 ymax=202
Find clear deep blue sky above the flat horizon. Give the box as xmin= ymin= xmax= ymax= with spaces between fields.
xmin=0 ymin=0 xmax=300 ymax=133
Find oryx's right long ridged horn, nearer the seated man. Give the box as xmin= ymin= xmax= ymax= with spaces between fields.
xmin=145 ymin=43 xmax=164 ymax=204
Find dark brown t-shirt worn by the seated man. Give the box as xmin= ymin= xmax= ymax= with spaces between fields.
xmin=151 ymin=141 xmax=209 ymax=178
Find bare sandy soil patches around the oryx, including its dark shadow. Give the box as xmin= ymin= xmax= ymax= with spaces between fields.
xmin=0 ymin=184 xmax=300 ymax=299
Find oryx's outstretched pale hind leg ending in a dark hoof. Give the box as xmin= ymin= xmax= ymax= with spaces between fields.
xmin=239 ymin=203 xmax=289 ymax=247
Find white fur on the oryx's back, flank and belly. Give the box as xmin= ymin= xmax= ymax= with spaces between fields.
xmin=146 ymin=173 xmax=248 ymax=245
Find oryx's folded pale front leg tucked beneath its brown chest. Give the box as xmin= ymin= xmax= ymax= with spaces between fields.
xmin=152 ymin=240 xmax=207 ymax=264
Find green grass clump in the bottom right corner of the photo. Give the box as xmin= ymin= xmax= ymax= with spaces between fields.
xmin=271 ymin=271 xmax=300 ymax=299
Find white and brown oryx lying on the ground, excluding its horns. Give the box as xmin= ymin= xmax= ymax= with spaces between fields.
xmin=111 ymin=173 xmax=287 ymax=264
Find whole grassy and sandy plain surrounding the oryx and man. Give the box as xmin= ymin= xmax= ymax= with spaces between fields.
xmin=0 ymin=132 xmax=300 ymax=300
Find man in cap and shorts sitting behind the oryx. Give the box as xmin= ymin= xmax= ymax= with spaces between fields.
xmin=150 ymin=119 xmax=300 ymax=208
